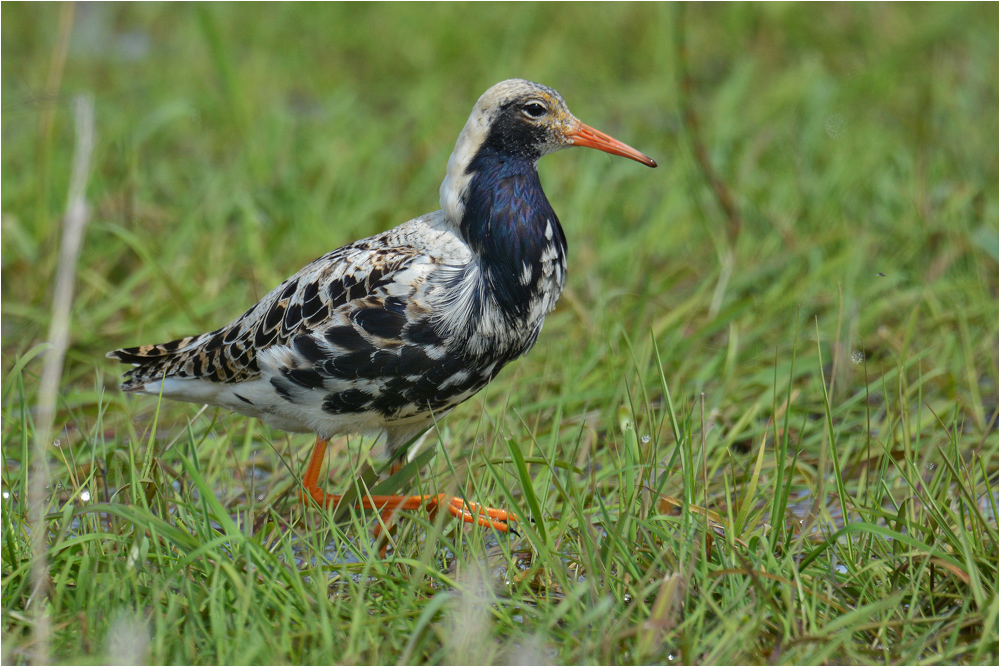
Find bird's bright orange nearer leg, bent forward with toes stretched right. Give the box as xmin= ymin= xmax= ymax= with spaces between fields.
xmin=300 ymin=438 xmax=518 ymax=533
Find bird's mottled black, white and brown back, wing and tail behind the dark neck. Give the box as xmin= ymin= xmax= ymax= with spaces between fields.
xmin=108 ymin=214 xmax=537 ymax=438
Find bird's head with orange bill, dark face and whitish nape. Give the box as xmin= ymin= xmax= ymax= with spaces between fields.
xmin=441 ymin=79 xmax=656 ymax=221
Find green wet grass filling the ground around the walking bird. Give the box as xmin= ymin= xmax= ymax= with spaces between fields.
xmin=0 ymin=3 xmax=1000 ymax=664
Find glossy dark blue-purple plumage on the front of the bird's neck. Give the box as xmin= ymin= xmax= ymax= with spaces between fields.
xmin=461 ymin=142 xmax=566 ymax=322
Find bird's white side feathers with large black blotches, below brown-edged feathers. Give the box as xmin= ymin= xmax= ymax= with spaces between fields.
xmin=258 ymin=256 xmax=504 ymax=422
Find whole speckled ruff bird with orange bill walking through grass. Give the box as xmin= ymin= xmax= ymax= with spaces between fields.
xmin=107 ymin=79 xmax=656 ymax=530
